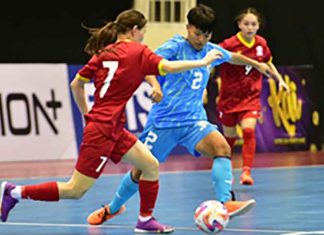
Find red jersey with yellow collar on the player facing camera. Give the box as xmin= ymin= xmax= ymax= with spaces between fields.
xmin=217 ymin=33 xmax=272 ymax=113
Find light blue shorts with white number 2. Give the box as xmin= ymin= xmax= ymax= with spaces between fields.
xmin=139 ymin=121 xmax=218 ymax=162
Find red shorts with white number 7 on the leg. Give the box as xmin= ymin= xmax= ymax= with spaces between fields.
xmin=75 ymin=122 xmax=137 ymax=179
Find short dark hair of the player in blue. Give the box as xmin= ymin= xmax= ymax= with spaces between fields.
xmin=187 ymin=4 xmax=216 ymax=33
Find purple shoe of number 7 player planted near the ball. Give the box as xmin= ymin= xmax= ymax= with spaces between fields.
xmin=134 ymin=217 xmax=174 ymax=233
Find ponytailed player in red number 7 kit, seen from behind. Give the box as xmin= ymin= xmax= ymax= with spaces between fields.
xmin=0 ymin=10 xmax=222 ymax=233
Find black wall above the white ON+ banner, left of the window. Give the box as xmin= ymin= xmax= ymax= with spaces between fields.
xmin=0 ymin=0 xmax=133 ymax=64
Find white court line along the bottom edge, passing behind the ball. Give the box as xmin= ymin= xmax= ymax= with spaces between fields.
xmin=0 ymin=222 xmax=298 ymax=235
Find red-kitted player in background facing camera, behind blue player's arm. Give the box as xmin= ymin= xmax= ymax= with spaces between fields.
xmin=217 ymin=8 xmax=289 ymax=185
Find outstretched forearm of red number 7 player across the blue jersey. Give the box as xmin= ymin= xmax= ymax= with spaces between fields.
xmin=159 ymin=49 xmax=223 ymax=75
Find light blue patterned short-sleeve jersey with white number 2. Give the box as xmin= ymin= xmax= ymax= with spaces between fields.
xmin=148 ymin=35 xmax=231 ymax=128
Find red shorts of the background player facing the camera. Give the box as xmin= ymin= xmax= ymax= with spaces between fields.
xmin=218 ymin=110 xmax=260 ymax=126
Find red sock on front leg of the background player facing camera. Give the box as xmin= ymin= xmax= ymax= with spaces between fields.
xmin=242 ymin=128 xmax=256 ymax=168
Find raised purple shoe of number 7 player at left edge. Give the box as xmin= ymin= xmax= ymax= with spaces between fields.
xmin=0 ymin=181 xmax=18 ymax=222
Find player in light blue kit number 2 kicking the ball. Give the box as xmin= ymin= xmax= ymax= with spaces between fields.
xmin=88 ymin=5 xmax=274 ymax=228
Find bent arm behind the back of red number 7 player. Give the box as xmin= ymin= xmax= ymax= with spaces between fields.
xmin=70 ymin=74 xmax=89 ymax=115
